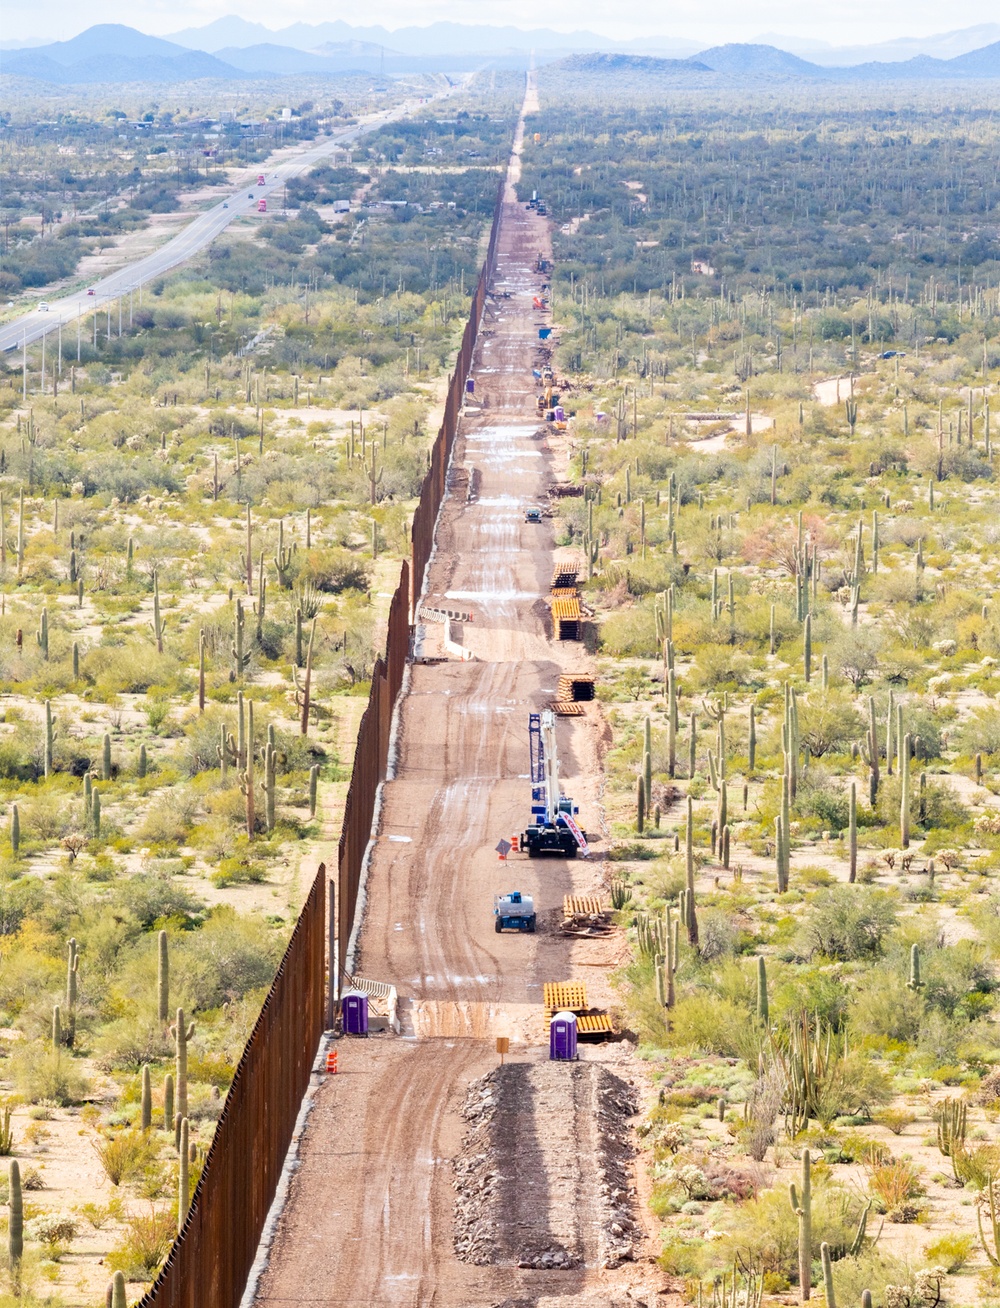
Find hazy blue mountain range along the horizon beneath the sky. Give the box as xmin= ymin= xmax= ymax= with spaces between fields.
xmin=0 ymin=17 xmax=1000 ymax=85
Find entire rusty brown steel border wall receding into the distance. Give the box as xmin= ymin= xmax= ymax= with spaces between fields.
xmin=139 ymin=173 xmax=503 ymax=1308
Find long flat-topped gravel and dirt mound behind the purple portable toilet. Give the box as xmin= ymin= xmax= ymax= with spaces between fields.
xmin=455 ymin=1062 xmax=638 ymax=1270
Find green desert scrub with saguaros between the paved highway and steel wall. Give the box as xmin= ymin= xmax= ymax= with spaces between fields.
xmin=0 ymin=74 xmax=514 ymax=1304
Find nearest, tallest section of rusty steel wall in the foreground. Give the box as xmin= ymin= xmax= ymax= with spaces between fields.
xmin=140 ymin=863 xmax=327 ymax=1308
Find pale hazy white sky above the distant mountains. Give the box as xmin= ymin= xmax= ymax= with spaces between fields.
xmin=3 ymin=0 xmax=1000 ymax=46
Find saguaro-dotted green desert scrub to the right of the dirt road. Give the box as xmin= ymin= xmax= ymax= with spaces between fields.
xmin=530 ymin=71 xmax=1000 ymax=1305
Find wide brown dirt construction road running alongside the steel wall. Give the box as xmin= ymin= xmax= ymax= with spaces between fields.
xmin=256 ymin=79 xmax=663 ymax=1308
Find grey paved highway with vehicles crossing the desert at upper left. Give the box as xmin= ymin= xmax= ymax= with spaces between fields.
xmin=0 ymin=92 xmax=439 ymax=351
